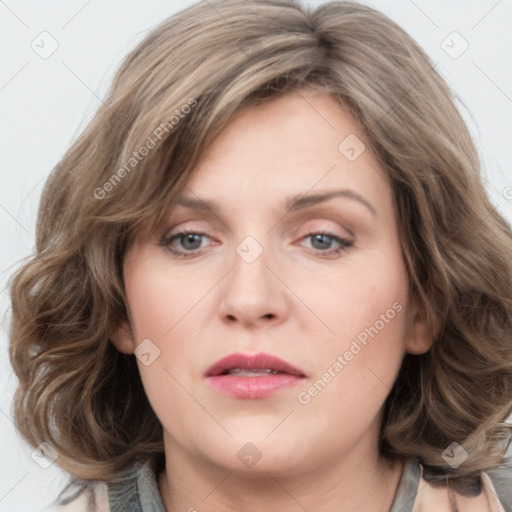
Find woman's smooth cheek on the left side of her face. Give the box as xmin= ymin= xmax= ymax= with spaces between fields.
xmin=125 ymin=254 xmax=208 ymax=394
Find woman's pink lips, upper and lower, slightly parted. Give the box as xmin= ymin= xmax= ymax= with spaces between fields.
xmin=205 ymin=353 xmax=306 ymax=398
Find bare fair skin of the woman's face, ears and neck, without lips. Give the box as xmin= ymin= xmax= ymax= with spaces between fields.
xmin=112 ymin=90 xmax=432 ymax=512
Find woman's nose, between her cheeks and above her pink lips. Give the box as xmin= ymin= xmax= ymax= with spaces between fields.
xmin=215 ymin=236 xmax=288 ymax=328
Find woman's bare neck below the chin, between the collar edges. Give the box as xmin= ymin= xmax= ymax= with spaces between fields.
xmin=158 ymin=436 xmax=403 ymax=512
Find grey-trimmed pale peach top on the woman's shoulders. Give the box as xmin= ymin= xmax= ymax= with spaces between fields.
xmin=43 ymin=459 xmax=512 ymax=512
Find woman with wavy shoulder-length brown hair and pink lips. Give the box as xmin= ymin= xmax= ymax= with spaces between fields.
xmin=10 ymin=0 xmax=512 ymax=512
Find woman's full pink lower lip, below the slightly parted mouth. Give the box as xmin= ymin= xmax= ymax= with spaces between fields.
xmin=208 ymin=374 xmax=302 ymax=398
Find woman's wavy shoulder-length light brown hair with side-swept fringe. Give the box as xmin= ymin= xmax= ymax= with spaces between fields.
xmin=10 ymin=0 xmax=512 ymax=496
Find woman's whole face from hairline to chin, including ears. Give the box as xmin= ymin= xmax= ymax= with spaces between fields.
xmin=113 ymin=91 xmax=430 ymax=474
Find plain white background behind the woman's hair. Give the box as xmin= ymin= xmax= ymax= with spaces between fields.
xmin=0 ymin=0 xmax=512 ymax=512
